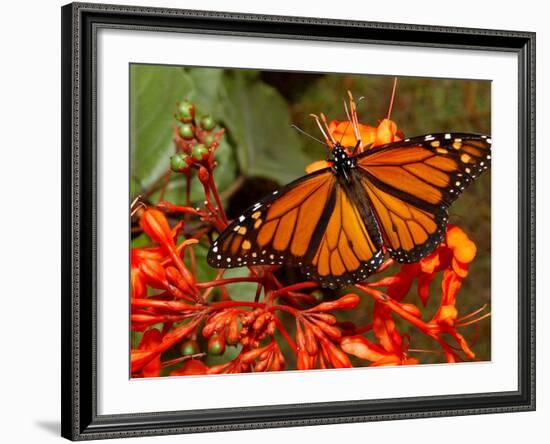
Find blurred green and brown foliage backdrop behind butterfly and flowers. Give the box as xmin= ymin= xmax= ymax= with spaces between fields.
xmin=130 ymin=64 xmax=491 ymax=365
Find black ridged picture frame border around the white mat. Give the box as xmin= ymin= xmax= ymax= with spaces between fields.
xmin=61 ymin=3 xmax=535 ymax=440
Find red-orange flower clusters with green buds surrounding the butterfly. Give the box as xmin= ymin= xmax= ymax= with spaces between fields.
xmin=130 ymin=102 xmax=488 ymax=377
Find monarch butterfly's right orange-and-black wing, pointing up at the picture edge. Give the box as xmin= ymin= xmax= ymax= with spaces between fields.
xmin=356 ymin=133 xmax=491 ymax=262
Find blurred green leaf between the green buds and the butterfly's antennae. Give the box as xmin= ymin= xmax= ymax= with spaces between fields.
xmin=219 ymin=71 xmax=308 ymax=183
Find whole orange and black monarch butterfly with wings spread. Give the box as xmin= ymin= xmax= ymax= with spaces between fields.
xmin=207 ymin=113 xmax=491 ymax=289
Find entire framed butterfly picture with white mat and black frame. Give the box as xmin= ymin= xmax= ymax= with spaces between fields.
xmin=62 ymin=3 xmax=535 ymax=440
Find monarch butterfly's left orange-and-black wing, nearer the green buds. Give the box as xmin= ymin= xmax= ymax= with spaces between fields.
xmin=207 ymin=169 xmax=382 ymax=288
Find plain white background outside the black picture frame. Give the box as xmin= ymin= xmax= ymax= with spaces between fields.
xmin=0 ymin=0 xmax=550 ymax=443
